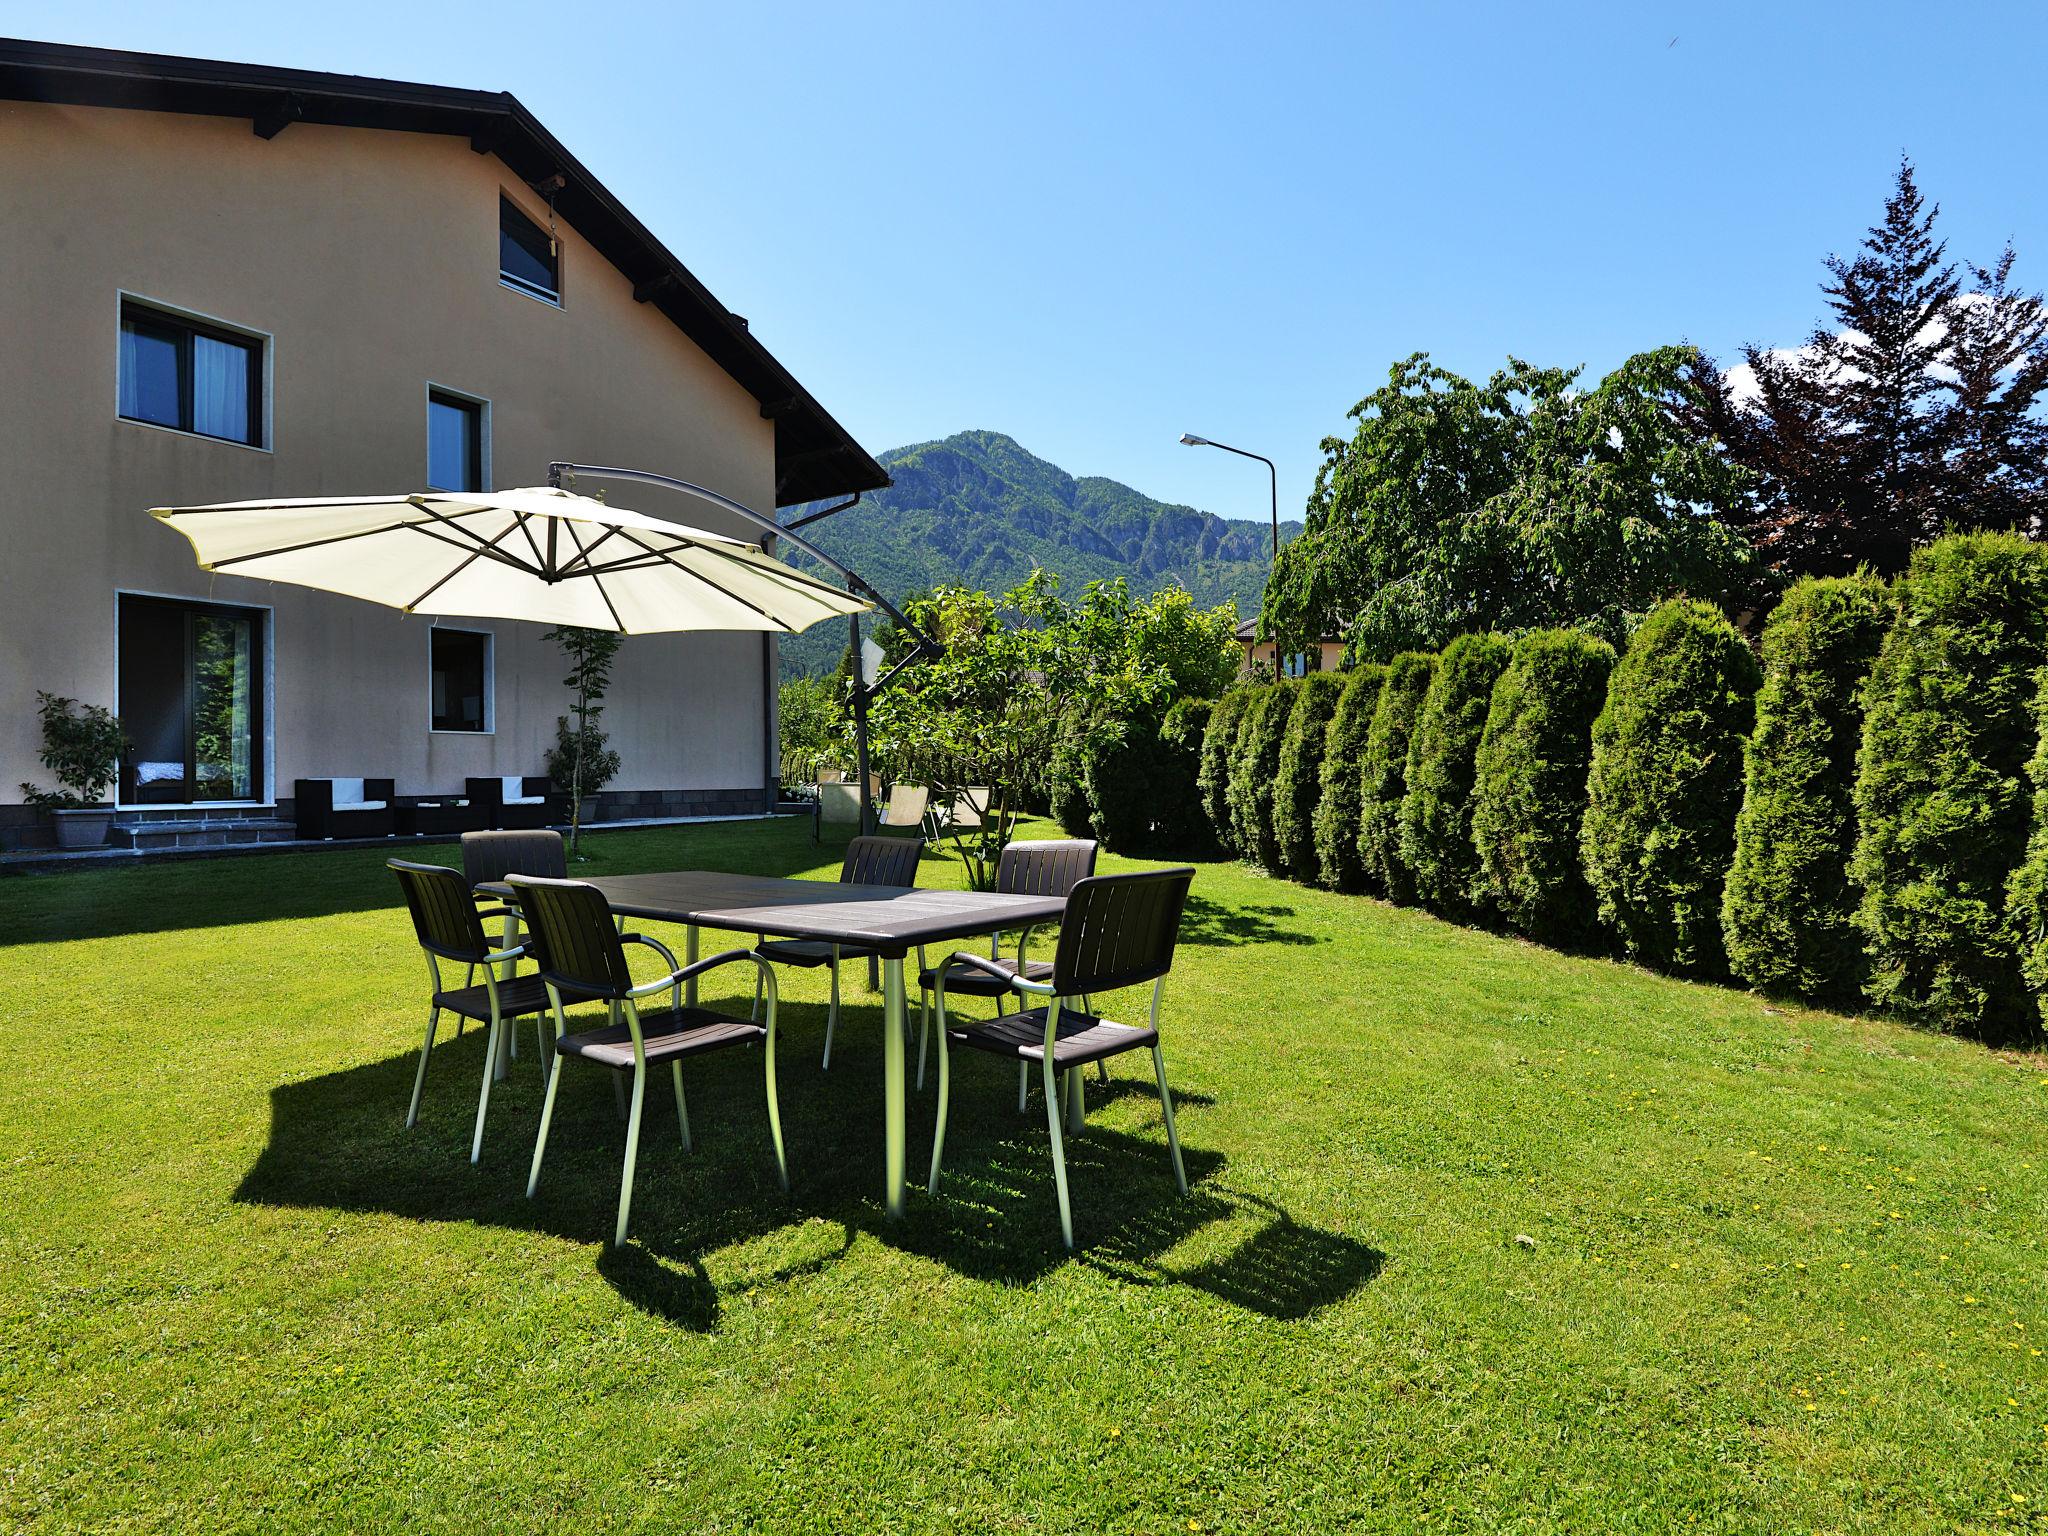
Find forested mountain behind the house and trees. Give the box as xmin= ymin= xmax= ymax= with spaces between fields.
xmin=782 ymin=432 xmax=1300 ymax=676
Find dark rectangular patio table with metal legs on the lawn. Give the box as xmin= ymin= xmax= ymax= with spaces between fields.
xmin=477 ymin=870 xmax=1067 ymax=1217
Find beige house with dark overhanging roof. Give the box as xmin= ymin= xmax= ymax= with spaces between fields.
xmin=0 ymin=41 xmax=889 ymax=846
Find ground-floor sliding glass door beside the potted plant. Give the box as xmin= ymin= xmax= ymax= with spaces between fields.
xmin=121 ymin=596 xmax=264 ymax=805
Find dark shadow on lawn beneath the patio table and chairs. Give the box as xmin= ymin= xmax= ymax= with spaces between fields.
xmin=236 ymin=1008 xmax=1378 ymax=1331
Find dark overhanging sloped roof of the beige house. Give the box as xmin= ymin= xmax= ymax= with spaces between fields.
xmin=0 ymin=39 xmax=889 ymax=506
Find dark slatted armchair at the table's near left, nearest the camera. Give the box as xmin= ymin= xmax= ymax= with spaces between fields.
xmin=510 ymin=874 xmax=788 ymax=1247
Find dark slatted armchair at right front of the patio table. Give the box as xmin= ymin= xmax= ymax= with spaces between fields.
xmin=926 ymin=866 xmax=1194 ymax=1249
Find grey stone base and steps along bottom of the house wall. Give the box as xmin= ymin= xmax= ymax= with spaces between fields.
xmin=0 ymin=788 xmax=778 ymax=866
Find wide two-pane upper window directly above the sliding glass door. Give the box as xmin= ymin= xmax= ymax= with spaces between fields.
xmin=121 ymin=301 xmax=262 ymax=446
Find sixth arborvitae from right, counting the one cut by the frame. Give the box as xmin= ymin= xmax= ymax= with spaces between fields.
xmin=1401 ymin=635 xmax=1513 ymax=918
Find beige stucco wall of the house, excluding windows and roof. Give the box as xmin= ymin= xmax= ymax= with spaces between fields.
xmin=0 ymin=102 xmax=790 ymax=823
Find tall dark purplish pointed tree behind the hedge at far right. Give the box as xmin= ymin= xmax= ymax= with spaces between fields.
xmin=1688 ymin=162 xmax=2048 ymax=575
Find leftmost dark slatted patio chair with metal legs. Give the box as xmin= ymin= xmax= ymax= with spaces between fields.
xmin=387 ymin=858 xmax=547 ymax=1163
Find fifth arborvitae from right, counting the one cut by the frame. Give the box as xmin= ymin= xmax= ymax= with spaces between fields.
xmin=1473 ymin=629 xmax=1614 ymax=944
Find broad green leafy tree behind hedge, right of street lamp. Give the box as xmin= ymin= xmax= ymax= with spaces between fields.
xmin=1262 ymin=346 xmax=1755 ymax=659
